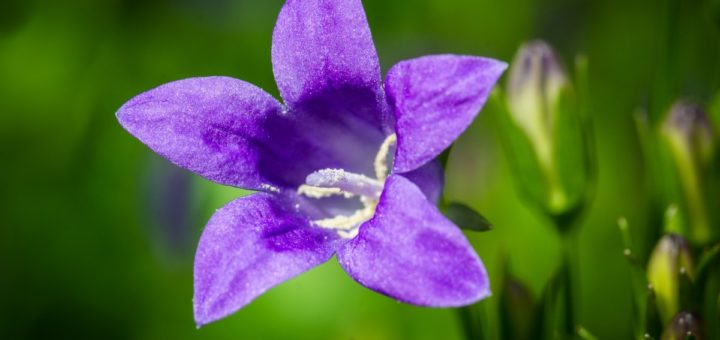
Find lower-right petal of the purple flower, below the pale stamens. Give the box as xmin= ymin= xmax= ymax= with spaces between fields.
xmin=338 ymin=175 xmax=490 ymax=307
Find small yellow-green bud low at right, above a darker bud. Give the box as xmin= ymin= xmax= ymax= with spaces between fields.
xmin=647 ymin=234 xmax=694 ymax=323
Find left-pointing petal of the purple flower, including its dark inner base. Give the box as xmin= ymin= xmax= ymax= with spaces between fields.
xmin=117 ymin=77 xmax=382 ymax=191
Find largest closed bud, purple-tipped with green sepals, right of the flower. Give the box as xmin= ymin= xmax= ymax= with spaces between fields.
xmin=503 ymin=41 xmax=589 ymax=220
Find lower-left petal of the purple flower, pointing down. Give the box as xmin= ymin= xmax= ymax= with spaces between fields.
xmin=193 ymin=193 xmax=339 ymax=326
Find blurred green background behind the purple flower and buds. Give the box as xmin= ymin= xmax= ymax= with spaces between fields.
xmin=0 ymin=0 xmax=720 ymax=339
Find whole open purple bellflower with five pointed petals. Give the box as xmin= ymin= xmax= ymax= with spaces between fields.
xmin=117 ymin=0 xmax=507 ymax=325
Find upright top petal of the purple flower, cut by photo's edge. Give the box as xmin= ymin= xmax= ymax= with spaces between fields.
xmin=272 ymin=0 xmax=388 ymax=135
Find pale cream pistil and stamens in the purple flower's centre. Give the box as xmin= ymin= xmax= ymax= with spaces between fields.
xmin=298 ymin=134 xmax=397 ymax=238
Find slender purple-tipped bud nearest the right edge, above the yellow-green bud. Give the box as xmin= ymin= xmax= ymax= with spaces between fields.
xmin=661 ymin=101 xmax=716 ymax=244
